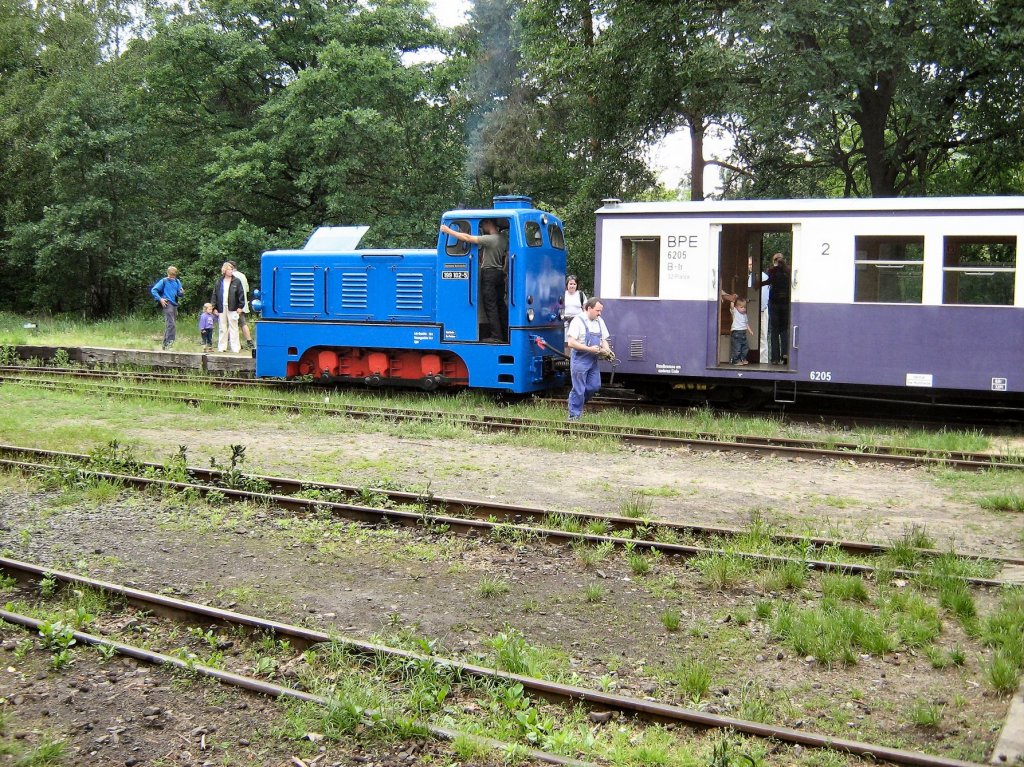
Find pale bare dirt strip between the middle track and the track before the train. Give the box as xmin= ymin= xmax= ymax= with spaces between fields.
xmin=157 ymin=419 xmax=1024 ymax=557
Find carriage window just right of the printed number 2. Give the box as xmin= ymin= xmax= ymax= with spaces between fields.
xmin=853 ymin=237 xmax=925 ymax=303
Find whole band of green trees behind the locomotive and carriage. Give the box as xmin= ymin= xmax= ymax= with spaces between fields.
xmin=0 ymin=0 xmax=1024 ymax=315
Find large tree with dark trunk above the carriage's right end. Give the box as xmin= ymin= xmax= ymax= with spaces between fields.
xmin=733 ymin=0 xmax=1024 ymax=197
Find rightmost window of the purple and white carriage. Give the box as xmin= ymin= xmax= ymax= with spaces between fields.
xmin=942 ymin=237 xmax=1017 ymax=306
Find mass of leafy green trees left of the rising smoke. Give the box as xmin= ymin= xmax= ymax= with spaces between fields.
xmin=0 ymin=0 xmax=465 ymax=315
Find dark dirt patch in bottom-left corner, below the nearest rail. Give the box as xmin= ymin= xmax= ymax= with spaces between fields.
xmin=0 ymin=626 xmax=456 ymax=767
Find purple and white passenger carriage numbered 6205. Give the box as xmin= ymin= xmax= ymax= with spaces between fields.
xmin=595 ymin=197 xmax=1024 ymax=401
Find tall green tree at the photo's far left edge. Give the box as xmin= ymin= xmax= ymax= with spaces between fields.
xmin=5 ymin=0 xmax=154 ymax=316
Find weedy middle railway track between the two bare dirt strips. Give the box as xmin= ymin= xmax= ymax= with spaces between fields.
xmin=0 ymin=445 xmax=1007 ymax=587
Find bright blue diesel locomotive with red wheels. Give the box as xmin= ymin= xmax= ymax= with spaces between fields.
xmin=254 ymin=196 xmax=566 ymax=394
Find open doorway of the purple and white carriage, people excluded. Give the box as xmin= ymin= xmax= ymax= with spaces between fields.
xmin=709 ymin=222 xmax=799 ymax=371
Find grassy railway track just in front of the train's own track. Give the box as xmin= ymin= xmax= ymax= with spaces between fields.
xmin=0 ymin=369 xmax=1024 ymax=471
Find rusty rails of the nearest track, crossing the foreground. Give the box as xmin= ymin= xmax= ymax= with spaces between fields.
xmin=0 ymin=557 xmax=991 ymax=767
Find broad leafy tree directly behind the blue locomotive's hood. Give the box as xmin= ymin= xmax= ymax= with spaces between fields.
xmin=200 ymin=0 xmax=463 ymax=245
